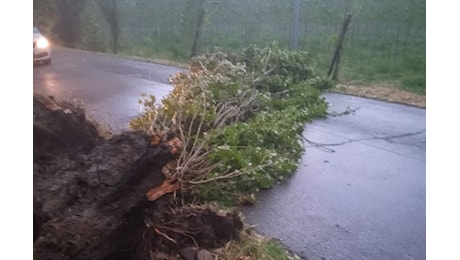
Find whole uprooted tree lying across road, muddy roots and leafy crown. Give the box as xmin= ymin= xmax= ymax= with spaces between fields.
xmin=34 ymin=46 xmax=329 ymax=259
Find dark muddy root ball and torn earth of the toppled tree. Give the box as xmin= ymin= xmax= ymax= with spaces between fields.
xmin=33 ymin=96 xmax=243 ymax=260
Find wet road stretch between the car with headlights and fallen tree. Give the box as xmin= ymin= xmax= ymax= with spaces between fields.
xmin=33 ymin=47 xmax=181 ymax=130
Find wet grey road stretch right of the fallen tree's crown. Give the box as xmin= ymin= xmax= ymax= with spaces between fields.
xmin=244 ymin=93 xmax=426 ymax=260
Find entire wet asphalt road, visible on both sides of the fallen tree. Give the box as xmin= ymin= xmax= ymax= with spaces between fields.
xmin=34 ymin=48 xmax=426 ymax=260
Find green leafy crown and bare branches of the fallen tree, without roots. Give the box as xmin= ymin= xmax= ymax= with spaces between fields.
xmin=131 ymin=45 xmax=330 ymax=204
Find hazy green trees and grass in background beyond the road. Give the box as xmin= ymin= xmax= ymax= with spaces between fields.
xmin=34 ymin=0 xmax=426 ymax=94
